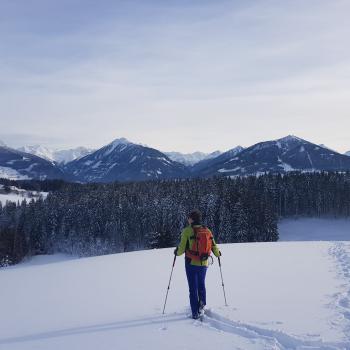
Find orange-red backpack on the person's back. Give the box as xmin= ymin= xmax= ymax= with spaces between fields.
xmin=186 ymin=226 xmax=213 ymax=262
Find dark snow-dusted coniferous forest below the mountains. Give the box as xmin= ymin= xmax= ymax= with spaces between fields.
xmin=0 ymin=173 xmax=350 ymax=266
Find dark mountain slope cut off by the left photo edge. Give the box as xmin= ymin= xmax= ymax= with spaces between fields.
xmin=0 ymin=146 xmax=64 ymax=180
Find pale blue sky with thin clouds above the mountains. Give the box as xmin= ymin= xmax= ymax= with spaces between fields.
xmin=0 ymin=0 xmax=350 ymax=152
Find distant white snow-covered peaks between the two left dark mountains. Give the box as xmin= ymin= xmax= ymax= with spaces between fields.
xmin=18 ymin=145 xmax=94 ymax=164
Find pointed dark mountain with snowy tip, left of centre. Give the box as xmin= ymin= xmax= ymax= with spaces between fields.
xmin=65 ymin=139 xmax=188 ymax=182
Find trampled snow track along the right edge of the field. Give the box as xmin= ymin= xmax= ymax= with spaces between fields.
xmin=329 ymin=242 xmax=350 ymax=340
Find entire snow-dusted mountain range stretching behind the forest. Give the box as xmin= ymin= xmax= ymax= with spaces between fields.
xmin=0 ymin=135 xmax=350 ymax=182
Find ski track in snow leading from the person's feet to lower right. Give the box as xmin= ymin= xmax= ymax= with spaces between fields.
xmin=197 ymin=309 xmax=349 ymax=350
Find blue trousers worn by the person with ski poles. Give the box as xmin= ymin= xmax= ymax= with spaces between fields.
xmin=185 ymin=259 xmax=207 ymax=315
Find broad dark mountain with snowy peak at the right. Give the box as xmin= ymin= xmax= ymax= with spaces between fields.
xmin=197 ymin=136 xmax=350 ymax=176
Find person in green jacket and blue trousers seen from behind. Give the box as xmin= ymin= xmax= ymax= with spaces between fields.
xmin=174 ymin=210 xmax=221 ymax=319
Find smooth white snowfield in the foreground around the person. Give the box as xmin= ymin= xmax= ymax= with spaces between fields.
xmin=0 ymin=241 xmax=350 ymax=350
